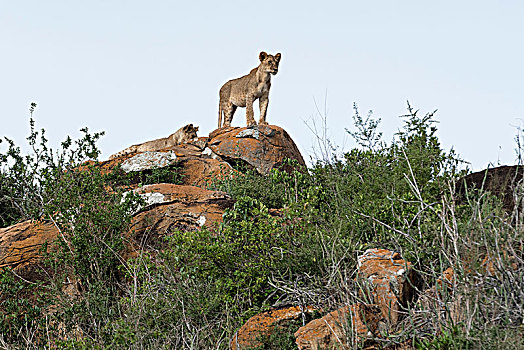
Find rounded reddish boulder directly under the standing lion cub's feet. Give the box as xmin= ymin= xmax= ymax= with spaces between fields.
xmin=208 ymin=125 xmax=305 ymax=175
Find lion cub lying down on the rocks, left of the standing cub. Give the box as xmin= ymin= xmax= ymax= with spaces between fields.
xmin=109 ymin=124 xmax=198 ymax=159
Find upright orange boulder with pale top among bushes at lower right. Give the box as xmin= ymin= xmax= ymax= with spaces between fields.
xmin=358 ymin=249 xmax=422 ymax=324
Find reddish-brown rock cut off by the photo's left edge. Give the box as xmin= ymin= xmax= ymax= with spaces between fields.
xmin=0 ymin=220 xmax=58 ymax=279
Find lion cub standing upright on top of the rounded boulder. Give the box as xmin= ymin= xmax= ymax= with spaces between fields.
xmin=218 ymin=51 xmax=281 ymax=128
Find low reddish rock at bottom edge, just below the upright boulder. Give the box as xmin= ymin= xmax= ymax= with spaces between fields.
xmin=295 ymin=303 xmax=382 ymax=350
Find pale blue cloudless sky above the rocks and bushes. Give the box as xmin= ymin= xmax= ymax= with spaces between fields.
xmin=0 ymin=0 xmax=524 ymax=170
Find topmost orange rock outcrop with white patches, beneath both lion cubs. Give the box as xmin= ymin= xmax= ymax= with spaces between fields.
xmin=98 ymin=125 xmax=305 ymax=187
